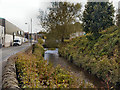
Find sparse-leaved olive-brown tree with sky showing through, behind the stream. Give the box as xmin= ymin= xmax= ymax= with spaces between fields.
xmin=38 ymin=2 xmax=81 ymax=42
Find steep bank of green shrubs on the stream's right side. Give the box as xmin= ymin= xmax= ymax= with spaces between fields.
xmin=59 ymin=26 xmax=120 ymax=86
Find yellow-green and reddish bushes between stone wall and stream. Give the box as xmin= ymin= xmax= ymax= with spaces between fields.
xmin=16 ymin=40 xmax=94 ymax=88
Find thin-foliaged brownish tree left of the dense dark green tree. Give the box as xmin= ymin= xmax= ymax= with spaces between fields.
xmin=38 ymin=1 xmax=82 ymax=42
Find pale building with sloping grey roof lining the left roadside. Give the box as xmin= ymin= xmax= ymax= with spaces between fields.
xmin=0 ymin=18 xmax=24 ymax=47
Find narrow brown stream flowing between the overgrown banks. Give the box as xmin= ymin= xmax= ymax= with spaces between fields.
xmin=44 ymin=48 xmax=105 ymax=88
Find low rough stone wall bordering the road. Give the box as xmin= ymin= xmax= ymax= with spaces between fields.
xmin=2 ymin=47 xmax=32 ymax=90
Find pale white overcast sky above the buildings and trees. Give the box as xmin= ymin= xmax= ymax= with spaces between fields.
xmin=0 ymin=0 xmax=119 ymax=32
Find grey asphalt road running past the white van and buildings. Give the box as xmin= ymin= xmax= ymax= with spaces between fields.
xmin=0 ymin=43 xmax=30 ymax=89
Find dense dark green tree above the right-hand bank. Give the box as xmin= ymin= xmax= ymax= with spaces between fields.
xmin=83 ymin=2 xmax=115 ymax=35
